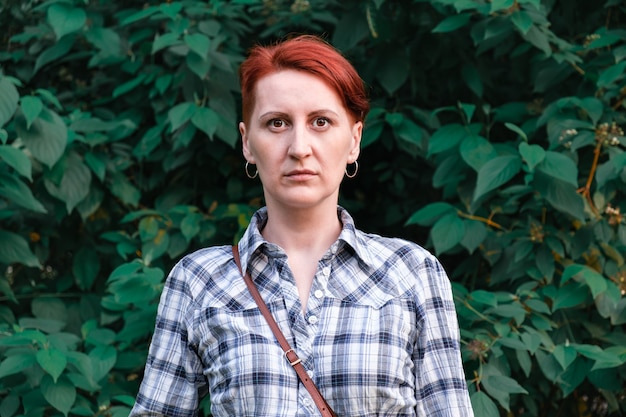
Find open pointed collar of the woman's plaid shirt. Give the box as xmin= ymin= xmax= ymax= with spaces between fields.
xmin=233 ymin=206 xmax=372 ymax=271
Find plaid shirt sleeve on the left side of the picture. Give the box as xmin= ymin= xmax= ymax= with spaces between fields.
xmin=130 ymin=259 xmax=207 ymax=417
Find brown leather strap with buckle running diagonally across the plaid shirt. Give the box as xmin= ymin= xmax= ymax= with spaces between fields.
xmin=233 ymin=245 xmax=337 ymax=417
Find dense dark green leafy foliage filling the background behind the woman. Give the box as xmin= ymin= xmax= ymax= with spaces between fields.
xmin=0 ymin=0 xmax=626 ymax=417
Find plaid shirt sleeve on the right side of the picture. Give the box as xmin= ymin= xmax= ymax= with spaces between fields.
xmin=414 ymin=255 xmax=474 ymax=417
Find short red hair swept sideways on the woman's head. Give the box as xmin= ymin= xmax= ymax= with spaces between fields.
xmin=239 ymin=35 xmax=369 ymax=123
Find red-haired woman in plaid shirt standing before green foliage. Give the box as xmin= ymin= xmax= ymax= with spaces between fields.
xmin=132 ymin=36 xmax=473 ymax=417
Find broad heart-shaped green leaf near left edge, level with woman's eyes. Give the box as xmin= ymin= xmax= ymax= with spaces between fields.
xmin=15 ymin=109 xmax=68 ymax=168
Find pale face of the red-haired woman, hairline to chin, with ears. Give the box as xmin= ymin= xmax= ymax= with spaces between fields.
xmin=239 ymin=70 xmax=363 ymax=208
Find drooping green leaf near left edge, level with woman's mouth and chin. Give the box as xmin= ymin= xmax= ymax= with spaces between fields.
xmin=44 ymin=152 xmax=91 ymax=213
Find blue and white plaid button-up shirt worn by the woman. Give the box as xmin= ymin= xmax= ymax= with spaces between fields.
xmin=131 ymin=208 xmax=473 ymax=417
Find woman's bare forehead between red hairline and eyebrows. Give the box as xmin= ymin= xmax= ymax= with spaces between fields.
xmin=253 ymin=70 xmax=346 ymax=112
